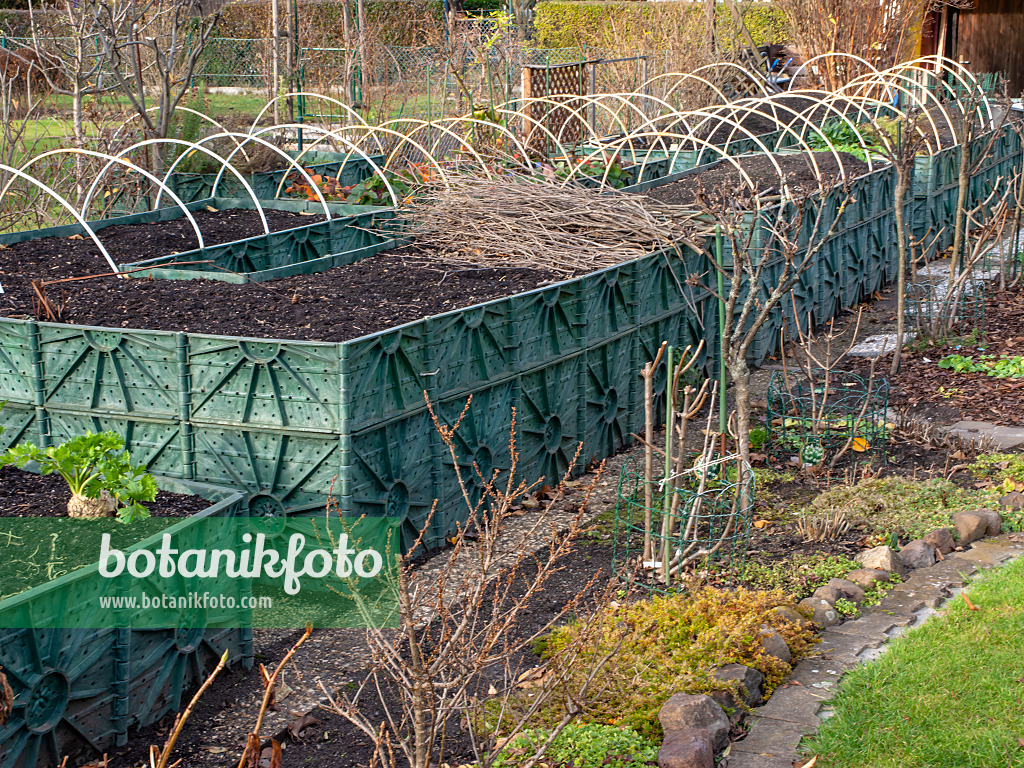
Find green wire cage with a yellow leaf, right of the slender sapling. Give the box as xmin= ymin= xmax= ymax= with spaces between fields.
xmin=765 ymin=371 xmax=894 ymax=468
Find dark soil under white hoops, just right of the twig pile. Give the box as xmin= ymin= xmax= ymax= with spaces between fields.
xmin=646 ymin=152 xmax=868 ymax=205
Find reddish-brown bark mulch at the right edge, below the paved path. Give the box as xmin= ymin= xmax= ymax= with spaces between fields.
xmin=862 ymin=289 xmax=1024 ymax=427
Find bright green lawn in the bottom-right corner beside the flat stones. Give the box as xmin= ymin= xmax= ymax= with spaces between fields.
xmin=804 ymin=559 xmax=1024 ymax=768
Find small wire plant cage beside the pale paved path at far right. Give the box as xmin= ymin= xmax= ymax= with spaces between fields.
xmin=904 ymin=280 xmax=985 ymax=338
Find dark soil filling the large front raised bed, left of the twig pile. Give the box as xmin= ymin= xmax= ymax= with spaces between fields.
xmin=0 ymin=211 xmax=558 ymax=342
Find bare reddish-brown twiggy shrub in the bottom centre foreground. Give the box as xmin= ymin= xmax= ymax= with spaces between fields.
xmin=326 ymin=398 xmax=617 ymax=768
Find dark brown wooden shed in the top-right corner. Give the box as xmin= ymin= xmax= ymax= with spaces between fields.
xmin=921 ymin=0 xmax=1024 ymax=97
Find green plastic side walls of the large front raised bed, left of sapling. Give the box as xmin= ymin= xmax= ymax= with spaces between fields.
xmin=0 ymin=208 xmax=710 ymax=543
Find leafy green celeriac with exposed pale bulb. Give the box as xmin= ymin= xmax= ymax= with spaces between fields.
xmin=0 ymin=432 xmax=158 ymax=523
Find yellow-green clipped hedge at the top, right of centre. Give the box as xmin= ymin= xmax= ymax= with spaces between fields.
xmin=534 ymin=0 xmax=788 ymax=48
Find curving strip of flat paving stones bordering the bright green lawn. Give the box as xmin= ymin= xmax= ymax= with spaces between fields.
xmin=727 ymin=534 xmax=1024 ymax=768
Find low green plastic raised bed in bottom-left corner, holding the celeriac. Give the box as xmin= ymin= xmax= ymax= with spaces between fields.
xmin=0 ymin=477 xmax=253 ymax=768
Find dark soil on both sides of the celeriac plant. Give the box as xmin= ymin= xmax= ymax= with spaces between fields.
xmin=0 ymin=467 xmax=210 ymax=517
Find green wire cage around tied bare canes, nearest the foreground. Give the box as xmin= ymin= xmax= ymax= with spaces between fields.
xmin=612 ymin=454 xmax=755 ymax=593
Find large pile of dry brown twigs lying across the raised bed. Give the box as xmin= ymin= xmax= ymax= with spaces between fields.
xmin=391 ymin=175 xmax=698 ymax=275
